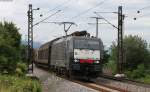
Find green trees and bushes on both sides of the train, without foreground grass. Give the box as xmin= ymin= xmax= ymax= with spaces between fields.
xmin=0 ymin=22 xmax=150 ymax=82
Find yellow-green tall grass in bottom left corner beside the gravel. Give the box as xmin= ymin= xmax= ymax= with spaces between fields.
xmin=0 ymin=76 xmax=41 ymax=92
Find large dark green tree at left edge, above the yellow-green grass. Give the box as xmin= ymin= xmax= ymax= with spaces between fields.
xmin=0 ymin=22 xmax=21 ymax=74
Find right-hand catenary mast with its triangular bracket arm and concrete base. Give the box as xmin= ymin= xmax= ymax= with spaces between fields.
xmin=94 ymin=6 xmax=125 ymax=77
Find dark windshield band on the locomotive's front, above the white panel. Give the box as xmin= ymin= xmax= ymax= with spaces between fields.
xmin=74 ymin=40 xmax=99 ymax=50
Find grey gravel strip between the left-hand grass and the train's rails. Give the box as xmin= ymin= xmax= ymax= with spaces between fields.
xmin=33 ymin=67 xmax=99 ymax=92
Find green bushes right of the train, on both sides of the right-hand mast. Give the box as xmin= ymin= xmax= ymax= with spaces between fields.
xmin=104 ymin=35 xmax=150 ymax=83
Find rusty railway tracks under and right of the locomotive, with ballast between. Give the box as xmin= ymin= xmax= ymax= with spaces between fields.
xmin=36 ymin=68 xmax=150 ymax=92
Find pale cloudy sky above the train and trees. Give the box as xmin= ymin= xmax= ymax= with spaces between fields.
xmin=0 ymin=0 xmax=150 ymax=47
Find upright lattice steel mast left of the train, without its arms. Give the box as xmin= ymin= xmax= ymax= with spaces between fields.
xmin=28 ymin=4 xmax=33 ymax=73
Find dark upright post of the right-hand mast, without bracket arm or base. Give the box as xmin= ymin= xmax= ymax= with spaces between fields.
xmin=117 ymin=6 xmax=125 ymax=74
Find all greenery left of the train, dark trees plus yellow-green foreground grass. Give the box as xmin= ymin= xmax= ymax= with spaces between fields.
xmin=0 ymin=21 xmax=41 ymax=92
